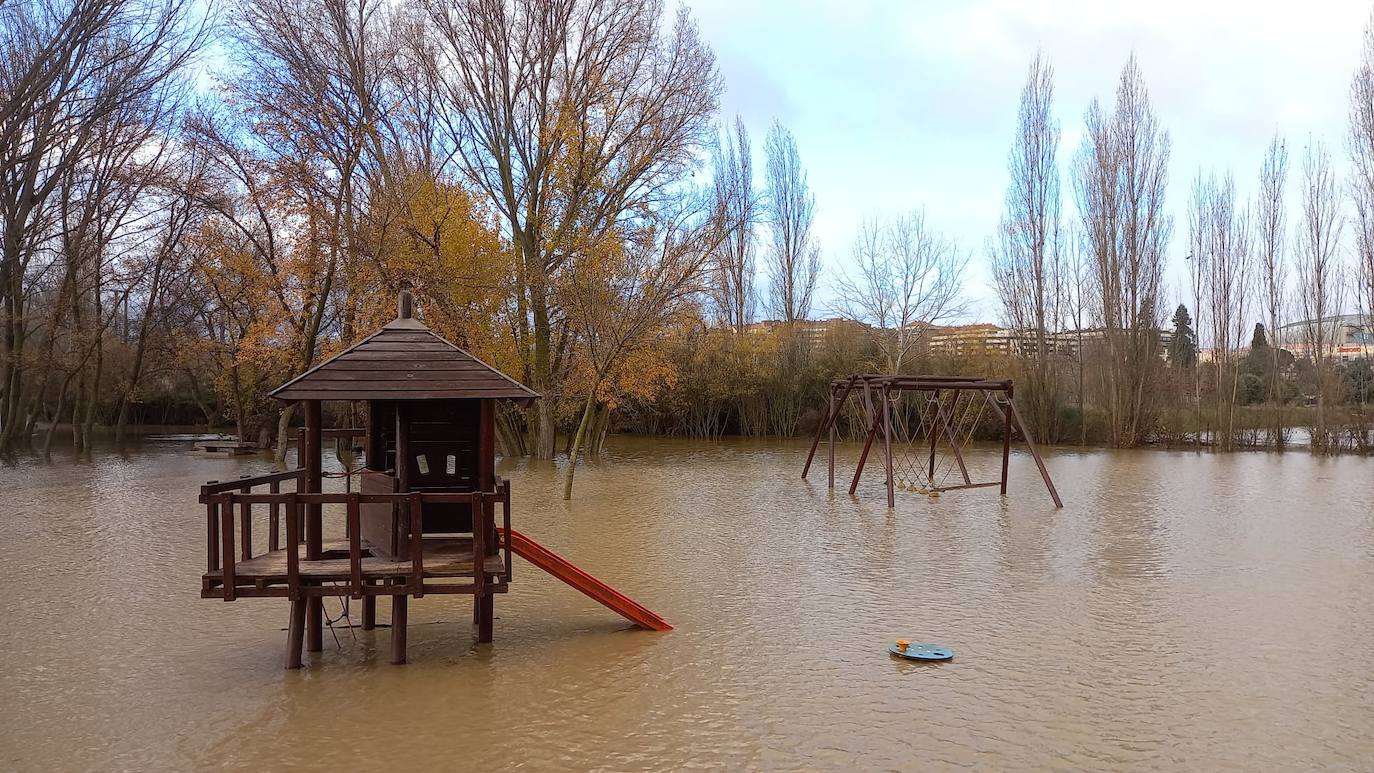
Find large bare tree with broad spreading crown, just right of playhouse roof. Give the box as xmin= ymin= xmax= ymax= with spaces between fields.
xmin=415 ymin=0 xmax=720 ymax=459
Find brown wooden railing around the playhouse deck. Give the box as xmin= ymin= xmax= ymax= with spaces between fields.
xmin=201 ymin=470 xmax=511 ymax=601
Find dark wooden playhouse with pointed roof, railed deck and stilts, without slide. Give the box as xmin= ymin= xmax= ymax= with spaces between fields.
xmin=201 ymin=294 xmax=539 ymax=667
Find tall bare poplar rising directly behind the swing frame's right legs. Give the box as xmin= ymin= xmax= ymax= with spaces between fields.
xmin=991 ymin=52 xmax=1063 ymax=442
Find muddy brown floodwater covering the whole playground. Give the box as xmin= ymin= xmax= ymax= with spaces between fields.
xmin=0 ymin=438 xmax=1374 ymax=770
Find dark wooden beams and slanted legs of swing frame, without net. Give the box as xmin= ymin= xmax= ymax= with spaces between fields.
xmin=801 ymin=373 xmax=1063 ymax=509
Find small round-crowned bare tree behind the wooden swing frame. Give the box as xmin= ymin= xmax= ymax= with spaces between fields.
xmin=835 ymin=210 xmax=969 ymax=373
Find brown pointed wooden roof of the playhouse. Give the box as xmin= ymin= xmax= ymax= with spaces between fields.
xmin=272 ymin=317 xmax=539 ymax=404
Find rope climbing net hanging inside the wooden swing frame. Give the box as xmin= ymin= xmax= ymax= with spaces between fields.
xmin=879 ymin=389 xmax=998 ymax=493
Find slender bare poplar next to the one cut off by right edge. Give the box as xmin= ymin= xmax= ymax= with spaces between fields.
xmin=1296 ymin=141 xmax=1344 ymax=453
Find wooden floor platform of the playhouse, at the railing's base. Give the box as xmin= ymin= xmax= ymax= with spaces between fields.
xmin=201 ymin=537 xmax=507 ymax=599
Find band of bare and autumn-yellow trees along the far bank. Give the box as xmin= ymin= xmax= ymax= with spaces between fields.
xmin=0 ymin=0 xmax=1374 ymax=477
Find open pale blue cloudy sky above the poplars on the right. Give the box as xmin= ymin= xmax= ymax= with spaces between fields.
xmin=687 ymin=0 xmax=1371 ymax=321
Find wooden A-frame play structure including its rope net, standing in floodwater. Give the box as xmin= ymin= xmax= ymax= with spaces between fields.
xmin=801 ymin=373 xmax=1063 ymax=508
